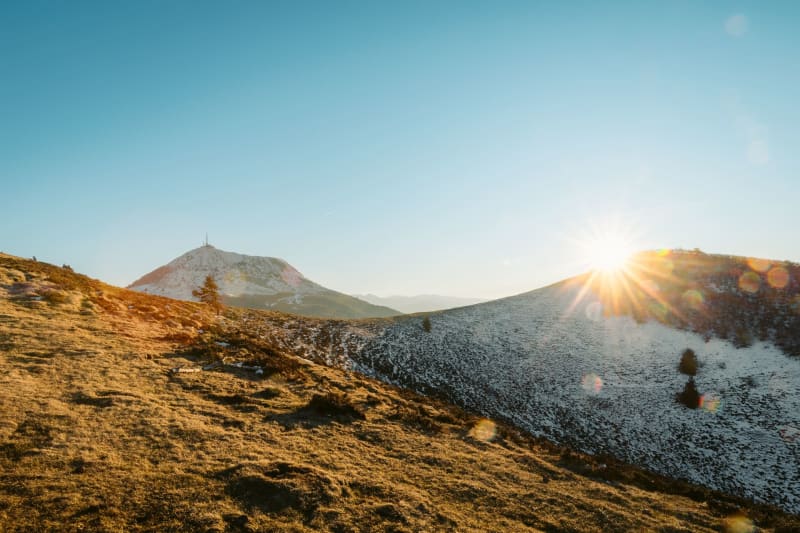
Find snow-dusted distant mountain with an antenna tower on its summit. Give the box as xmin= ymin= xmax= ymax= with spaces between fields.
xmin=128 ymin=245 xmax=401 ymax=318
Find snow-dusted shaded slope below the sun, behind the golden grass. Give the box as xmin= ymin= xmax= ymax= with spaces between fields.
xmin=341 ymin=283 xmax=800 ymax=512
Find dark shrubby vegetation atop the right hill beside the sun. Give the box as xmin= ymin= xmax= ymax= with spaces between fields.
xmin=579 ymin=250 xmax=800 ymax=356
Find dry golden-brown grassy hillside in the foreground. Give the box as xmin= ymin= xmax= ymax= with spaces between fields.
xmin=0 ymin=255 xmax=800 ymax=532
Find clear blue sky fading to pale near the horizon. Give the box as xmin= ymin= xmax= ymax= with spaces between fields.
xmin=0 ymin=0 xmax=800 ymax=298
